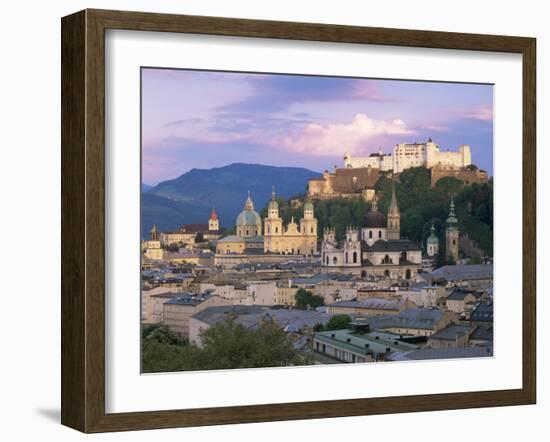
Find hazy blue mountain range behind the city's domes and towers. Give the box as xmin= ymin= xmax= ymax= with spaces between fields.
xmin=141 ymin=163 xmax=320 ymax=238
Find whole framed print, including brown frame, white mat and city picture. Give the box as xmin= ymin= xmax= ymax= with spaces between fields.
xmin=62 ymin=10 xmax=536 ymax=432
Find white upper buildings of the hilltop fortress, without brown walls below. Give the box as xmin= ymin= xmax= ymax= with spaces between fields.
xmin=344 ymin=138 xmax=472 ymax=173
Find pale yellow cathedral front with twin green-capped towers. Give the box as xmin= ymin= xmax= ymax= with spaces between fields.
xmin=264 ymin=189 xmax=317 ymax=255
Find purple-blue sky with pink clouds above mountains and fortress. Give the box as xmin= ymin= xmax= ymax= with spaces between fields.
xmin=142 ymin=68 xmax=493 ymax=184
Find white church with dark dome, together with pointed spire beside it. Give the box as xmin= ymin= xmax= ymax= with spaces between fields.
xmin=321 ymin=180 xmax=422 ymax=279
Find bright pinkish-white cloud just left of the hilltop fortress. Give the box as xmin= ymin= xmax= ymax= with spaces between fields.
xmin=282 ymin=114 xmax=415 ymax=156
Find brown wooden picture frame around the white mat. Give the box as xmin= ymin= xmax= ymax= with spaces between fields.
xmin=61 ymin=10 xmax=536 ymax=432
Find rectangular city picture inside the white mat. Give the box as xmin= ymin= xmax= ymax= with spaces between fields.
xmin=140 ymin=67 xmax=494 ymax=373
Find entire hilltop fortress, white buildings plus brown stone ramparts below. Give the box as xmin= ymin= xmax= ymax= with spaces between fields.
xmin=308 ymin=138 xmax=489 ymax=201
